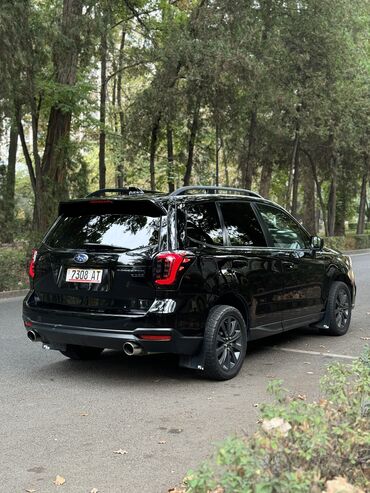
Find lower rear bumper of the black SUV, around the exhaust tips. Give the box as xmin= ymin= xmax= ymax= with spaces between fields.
xmin=25 ymin=318 xmax=203 ymax=355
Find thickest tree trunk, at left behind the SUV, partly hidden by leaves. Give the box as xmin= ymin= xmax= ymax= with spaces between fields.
xmin=34 ymin=0 xmax=82 ymax=234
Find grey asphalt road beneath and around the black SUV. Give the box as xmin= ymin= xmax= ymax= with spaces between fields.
xmin=0 ymin=253 xmax=370 ymax=493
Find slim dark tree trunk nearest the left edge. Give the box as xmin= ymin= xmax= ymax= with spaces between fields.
xmin=2 ymin=121 xmax=18 ymax=243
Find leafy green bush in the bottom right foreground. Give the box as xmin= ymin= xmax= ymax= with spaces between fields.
xmin=181 ymin=349 xmax=370 ymax=493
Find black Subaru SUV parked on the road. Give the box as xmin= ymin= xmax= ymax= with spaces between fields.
xmin=23 ymin=186 xmax=356 ymax=380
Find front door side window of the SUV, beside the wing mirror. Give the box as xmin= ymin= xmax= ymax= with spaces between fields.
xmin=258 ymin=204 xmax=309 ymax=249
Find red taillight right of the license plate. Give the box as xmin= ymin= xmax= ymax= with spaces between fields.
xmin=154 ymin=251 xmax=193 ymax=286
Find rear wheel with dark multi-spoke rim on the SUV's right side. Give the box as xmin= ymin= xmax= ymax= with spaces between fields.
xmin=204 ymin=305 xmax=247 ymax=380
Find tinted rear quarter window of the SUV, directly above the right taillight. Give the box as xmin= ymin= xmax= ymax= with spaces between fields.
xmin=186 ymin=202 xmax=223 ymax=245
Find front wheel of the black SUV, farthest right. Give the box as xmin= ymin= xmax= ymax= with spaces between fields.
xmin=326 ymin=281 xmax=352 ymax=336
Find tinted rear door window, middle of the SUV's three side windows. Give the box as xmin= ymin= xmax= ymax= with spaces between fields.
xmin=220 ymin=202 xmax=266 ymax=246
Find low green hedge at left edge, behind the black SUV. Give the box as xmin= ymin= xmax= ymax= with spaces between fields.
xmin=0 ymin=245 xmax=29 ymax=292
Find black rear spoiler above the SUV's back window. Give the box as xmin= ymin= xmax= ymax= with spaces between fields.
xmin=58 ymin=198 xmax=167 ymax=217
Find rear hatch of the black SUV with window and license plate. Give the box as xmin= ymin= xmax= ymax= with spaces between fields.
xmin=33 ymin=198 xmax=166 ymax=315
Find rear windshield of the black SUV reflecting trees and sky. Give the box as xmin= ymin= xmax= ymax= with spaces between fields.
xmin=45 ymin=214 xmax=161 ymax=250
